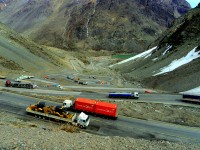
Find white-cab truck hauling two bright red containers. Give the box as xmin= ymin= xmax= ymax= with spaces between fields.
xmin=63 ymin=98 xmax=118 ymax=119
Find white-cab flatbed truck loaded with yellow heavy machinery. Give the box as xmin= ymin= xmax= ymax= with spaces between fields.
xmin=26 ymin=102 xmax=90 ymax=128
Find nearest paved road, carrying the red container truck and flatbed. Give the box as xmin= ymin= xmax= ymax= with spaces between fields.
xmin=0 ymin=92 xmax=200 ymax=143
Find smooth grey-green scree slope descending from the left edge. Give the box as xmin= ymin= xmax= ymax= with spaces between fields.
xmin=0 ymin=23 xmax=67 ymax=73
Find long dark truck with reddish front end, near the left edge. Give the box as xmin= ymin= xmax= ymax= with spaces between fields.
xmin=5 ymin=80 xmax=37 ymax=89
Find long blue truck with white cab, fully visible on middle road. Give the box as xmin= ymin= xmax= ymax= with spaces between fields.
xmin=108 ymin=92 xmax=139 ymax=99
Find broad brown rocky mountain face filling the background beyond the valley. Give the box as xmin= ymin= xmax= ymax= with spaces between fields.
xmin=0 ymin=0 xmax=190 ymax=52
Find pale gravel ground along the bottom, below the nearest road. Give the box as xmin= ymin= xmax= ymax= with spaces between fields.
xmin=0 ymin=112 xmax=200 ymax=150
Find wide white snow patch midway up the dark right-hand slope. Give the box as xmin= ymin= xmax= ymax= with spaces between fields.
xmin=153 ymin=47 xmax=200 ymax=76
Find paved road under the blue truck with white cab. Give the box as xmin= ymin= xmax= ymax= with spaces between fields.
xmin=0 ymin=86 xmax=200 ymax=107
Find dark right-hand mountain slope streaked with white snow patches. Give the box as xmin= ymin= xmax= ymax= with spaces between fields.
xmin=114 ymin=4 xmax=200 ymax=92
